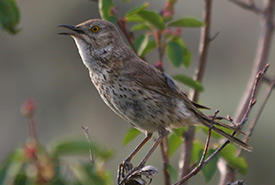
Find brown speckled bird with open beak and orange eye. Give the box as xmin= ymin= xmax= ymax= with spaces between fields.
xmin=59 ymin=19 xmax=252 ymax=181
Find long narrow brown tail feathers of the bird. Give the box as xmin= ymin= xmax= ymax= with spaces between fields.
xmin=201 ymin=116 xmax=252 ymax=152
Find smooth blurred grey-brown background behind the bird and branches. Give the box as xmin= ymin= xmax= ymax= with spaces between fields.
xmin=0 ymin=0 xmax=275 ymax=185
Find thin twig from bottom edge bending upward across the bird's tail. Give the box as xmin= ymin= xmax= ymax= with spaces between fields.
xmin=173 ymin=110 xmax=219 ymax=185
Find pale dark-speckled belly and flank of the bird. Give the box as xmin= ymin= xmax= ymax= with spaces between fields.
xmin=96 ymin=76 xmax=197 ymax=132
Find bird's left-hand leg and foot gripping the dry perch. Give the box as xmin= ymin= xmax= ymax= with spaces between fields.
xmin=117 ymin=132 xmax=153 ymax=182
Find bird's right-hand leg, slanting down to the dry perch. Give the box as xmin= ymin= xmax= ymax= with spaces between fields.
xmin=118 ymin=128 xmax=169 ymax=184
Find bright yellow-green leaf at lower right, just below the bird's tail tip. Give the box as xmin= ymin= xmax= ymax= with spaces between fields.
xmin=220 ymin=143 xmax=248 ymax=175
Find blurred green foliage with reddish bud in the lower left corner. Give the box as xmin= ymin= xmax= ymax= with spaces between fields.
xmin=0 ymin=99 xmax=113 ymax=185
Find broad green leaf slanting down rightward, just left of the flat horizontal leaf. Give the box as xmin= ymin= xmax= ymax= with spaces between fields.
xmin=137 ymin=10 xmax=165 ymax=30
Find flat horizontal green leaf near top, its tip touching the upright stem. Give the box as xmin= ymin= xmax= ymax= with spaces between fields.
xmin=168 ymin=17 xmax=205 ymax=27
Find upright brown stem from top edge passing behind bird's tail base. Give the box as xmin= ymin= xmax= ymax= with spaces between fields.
xmin=179 ymin=0 xmax=215 ymax=181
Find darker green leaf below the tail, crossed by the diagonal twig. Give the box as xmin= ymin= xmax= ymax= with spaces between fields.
xmin=200 ymin=148 xmax=219 ymax=182
